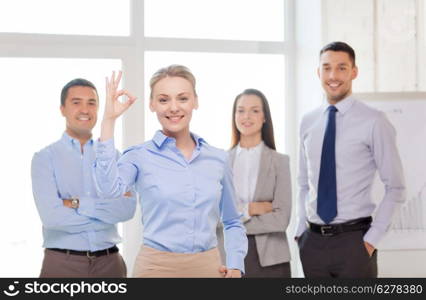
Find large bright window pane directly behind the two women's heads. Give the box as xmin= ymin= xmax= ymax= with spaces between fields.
xmin=145 ymin=52 xmax=285 ymax=151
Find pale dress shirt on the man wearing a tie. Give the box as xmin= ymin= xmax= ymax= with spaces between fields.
xmin=296 ymin=96 xmax=405 ymax=245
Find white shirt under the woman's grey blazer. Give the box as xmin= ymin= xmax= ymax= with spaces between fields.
xmin=233 ymin=141 xmax=264 ymax=221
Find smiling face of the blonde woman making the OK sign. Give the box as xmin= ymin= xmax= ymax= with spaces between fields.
xmin=150 ymin=77 xmax=198 ymax=135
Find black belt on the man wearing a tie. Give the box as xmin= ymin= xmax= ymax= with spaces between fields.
xmin=308 ymin=217 xmax=373 ymax=236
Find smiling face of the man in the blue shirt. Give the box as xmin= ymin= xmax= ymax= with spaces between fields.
xmin=61 ymin=86 xmax=99 ymax=138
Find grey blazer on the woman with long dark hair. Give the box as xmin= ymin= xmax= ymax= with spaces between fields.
xmin=219 ymin=145 xmax=292 ymax=267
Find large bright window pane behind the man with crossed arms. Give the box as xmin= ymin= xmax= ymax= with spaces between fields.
xmin=0 ymin=58 xmax=121 ymax=277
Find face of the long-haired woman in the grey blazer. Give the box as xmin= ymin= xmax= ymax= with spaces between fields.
xmin=235 ymin=95 xmax=265 ymax=136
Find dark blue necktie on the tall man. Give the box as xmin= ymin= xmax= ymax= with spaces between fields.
xmin=317 ymin=106 xmax=337 ymax=224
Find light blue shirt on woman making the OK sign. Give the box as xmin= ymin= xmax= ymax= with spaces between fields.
xmin=94 ymin=131 xmax=247 ymax=272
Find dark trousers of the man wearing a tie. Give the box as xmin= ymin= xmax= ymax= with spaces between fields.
xmin=297 ymin=229 xmax=377 ymax=278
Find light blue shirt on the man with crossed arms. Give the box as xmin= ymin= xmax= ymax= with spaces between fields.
xmin=31 ymin=133 xmax=136 ymax=251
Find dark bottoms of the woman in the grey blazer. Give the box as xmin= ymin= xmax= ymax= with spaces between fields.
xmin=244 ymin=235 xmax=291 ymax=278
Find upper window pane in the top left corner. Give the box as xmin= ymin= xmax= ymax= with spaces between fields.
xmin=0 ymin=0 xmax=130 ymax=36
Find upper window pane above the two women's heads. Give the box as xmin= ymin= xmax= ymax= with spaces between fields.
xmin=145 ymin=0 xmax=284 ymax=41
